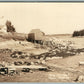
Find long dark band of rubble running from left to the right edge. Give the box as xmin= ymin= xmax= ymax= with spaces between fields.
xmin=11 ymin=48 xmax=84 ymax=60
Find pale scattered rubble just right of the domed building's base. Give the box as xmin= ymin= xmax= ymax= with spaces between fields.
xmin=42 ymin=37 xmax=74 ymax=48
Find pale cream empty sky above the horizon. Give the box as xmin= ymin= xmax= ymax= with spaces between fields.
xmin=0 ymin=2 xmax=84 ymax=34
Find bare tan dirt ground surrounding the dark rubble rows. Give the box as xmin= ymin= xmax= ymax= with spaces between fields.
xmin=0 ymin=36 xmax=84 ymax=82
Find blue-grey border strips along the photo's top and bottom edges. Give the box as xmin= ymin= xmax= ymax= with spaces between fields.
xmin=0 ymin=0 xmax=84 ymax=84
